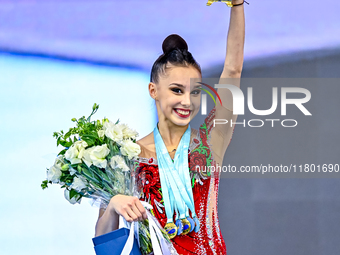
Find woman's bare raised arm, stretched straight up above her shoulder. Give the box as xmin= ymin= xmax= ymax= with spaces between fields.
xmin=212 ymin=0 xmax=245 ymax=160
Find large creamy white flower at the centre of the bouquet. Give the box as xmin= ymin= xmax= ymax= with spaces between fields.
xmin=83 ymin=144 xmax=110 ymax=168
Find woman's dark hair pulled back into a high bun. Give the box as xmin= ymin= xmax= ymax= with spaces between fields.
xmin=150 ymin=34 xmax=202 ymax=83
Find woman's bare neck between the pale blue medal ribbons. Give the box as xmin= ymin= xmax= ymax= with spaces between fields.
xmin=157 ymin=121 xmax=189 ymax=150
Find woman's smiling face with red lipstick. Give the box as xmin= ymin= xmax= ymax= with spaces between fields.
xmin=149 ymin=66 xmax=201 ymax=126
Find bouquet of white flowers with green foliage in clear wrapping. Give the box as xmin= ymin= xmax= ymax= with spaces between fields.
xmin=41 ymin=104 xmax=175 ymax=254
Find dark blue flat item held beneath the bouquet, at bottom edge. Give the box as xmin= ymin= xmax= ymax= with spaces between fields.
xmin=92 ymin=228 xmax=142 ymax=255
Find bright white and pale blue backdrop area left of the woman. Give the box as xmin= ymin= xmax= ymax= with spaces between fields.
xmin=0 ymin=54 xmax=156 ymax=255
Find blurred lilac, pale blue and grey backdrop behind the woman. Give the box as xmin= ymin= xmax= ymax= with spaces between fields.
xmin=0 ymin=0 xmax=340 ymax=255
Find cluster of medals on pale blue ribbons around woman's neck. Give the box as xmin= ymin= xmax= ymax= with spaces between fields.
xmin=154 ymin=125 xmax=200 ymax=239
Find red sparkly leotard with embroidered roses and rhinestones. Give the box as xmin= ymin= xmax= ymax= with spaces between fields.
xmin=135 ymin=104 xmax=233 ymax=255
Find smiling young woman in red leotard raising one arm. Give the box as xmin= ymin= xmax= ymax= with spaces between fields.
xmin=96 ymin=0 xmax=245 ymax=255
